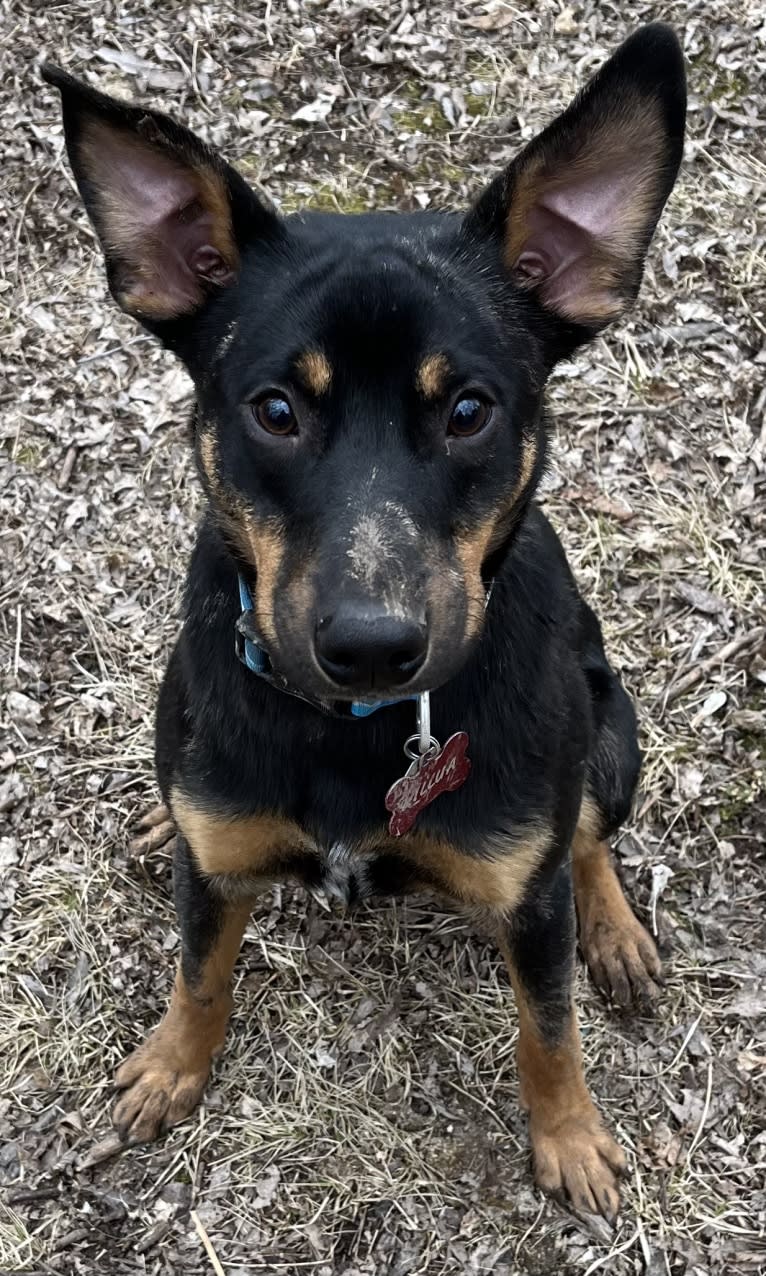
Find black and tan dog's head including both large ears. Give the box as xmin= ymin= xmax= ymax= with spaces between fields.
xmin=43 ymin=26 xmax=686 ymax=698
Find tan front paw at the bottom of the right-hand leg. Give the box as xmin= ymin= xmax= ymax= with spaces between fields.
xmin=530 ymin=1108 xmax=627 ymax=1222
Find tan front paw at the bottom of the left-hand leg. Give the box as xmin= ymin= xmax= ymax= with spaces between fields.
xmin=112 ymin=1025 xmax=211 ymax=1143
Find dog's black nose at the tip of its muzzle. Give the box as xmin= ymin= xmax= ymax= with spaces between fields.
xmin=315 ymin=602 xmax=428 ymax=690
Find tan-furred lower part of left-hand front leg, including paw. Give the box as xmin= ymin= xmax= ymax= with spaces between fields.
xmin=114 ymin=901 xmax=252 ymax=1143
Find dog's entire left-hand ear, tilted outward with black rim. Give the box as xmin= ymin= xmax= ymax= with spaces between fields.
xmin=42 ymin=63 xmax=280 ymax=327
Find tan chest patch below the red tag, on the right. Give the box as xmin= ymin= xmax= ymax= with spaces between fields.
xmin=391 ymin=828 xmax=552 ymax=912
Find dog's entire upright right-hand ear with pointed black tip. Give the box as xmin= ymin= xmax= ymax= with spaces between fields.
xmin=467 ymin=23 xmax=686 ymax=341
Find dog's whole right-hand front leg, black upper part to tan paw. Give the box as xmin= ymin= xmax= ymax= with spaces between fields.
xmin=500 ymin=864 xmax=626 ymax=1220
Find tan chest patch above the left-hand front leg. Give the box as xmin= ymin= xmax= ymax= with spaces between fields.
xmin=170 ymin=789 xmax=309 ymax=877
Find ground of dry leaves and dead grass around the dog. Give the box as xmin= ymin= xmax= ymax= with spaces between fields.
xmin=0 ymin=0 xmax=766 ymax=1276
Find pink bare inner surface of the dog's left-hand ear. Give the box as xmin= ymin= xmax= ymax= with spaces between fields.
xmin=88 ymin=125 xmax=234 ymax=318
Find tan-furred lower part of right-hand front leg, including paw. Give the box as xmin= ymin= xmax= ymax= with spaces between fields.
xmin=503 ymin=946 xmax=626 ymax=1220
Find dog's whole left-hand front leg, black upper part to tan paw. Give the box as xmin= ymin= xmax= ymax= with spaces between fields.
xmin=114 ymin=833 xmax=253 ymax=1143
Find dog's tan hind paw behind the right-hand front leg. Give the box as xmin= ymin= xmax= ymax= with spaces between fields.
xmin=580 ymin=905 xmax=663 ymax=1009
